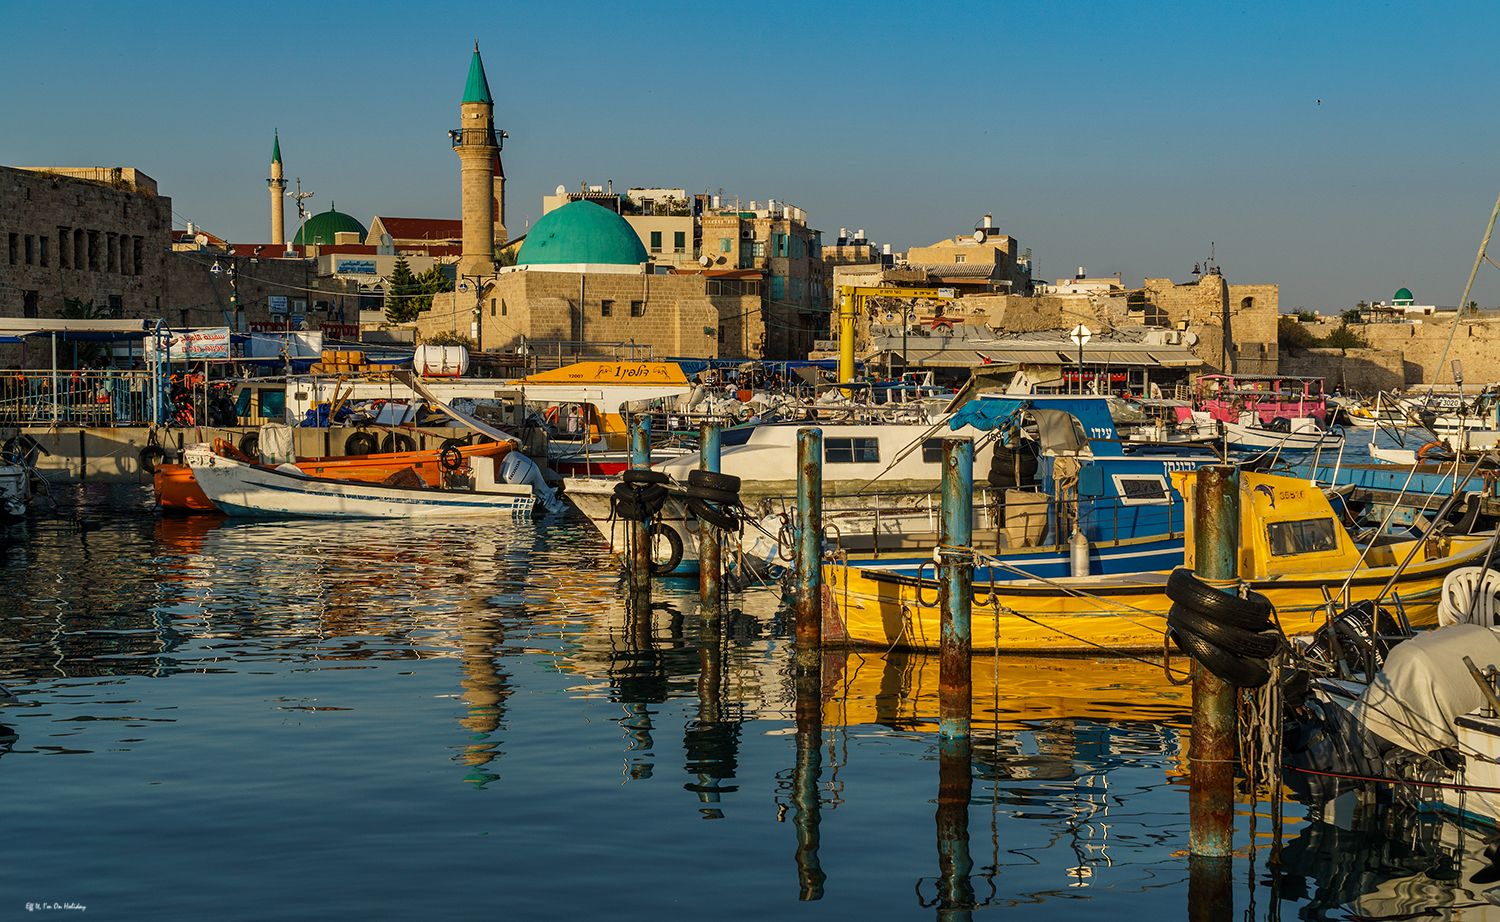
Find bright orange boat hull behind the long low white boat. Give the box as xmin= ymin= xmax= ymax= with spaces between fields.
xmin=153 ymin=439 xmax=516 ymax=514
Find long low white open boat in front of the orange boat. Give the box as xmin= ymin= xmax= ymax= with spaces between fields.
xmin=183 ymin=447 xmax=537 ymax=519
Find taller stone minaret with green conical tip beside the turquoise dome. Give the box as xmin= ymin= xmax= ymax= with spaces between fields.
xmin=453 ymin=42 xmax=501 ymax=276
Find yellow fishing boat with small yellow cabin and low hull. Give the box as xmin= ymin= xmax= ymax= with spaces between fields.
xmin=824 ymin=471 xmax=1494 ymax=655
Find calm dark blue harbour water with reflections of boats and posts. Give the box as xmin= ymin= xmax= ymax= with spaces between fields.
xmin=0 ymin=455 xmax=1484 ymax=919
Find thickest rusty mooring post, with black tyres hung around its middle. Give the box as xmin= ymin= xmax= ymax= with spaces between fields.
xmin=1188 ymin=466 xmax=1239 ymax=922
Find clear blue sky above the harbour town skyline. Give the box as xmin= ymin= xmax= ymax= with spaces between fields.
xmin=0 ymin=0 xmax=1500 ymax=312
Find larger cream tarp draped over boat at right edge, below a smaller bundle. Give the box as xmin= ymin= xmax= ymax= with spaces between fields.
xmin=1355 ymin=624 xmax=1500 ymax=753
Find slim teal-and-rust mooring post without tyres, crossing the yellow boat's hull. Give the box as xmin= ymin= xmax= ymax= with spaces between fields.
xmin=938 ymin=439 xmax=974 ymax=739
